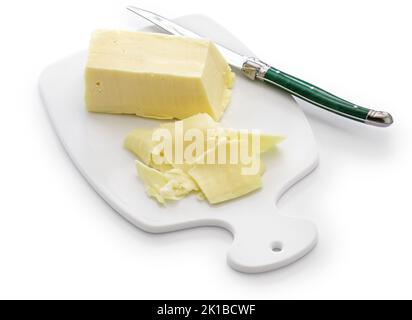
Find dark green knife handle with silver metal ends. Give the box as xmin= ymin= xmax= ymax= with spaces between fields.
xmin=242 ymin=58 xmax=393 ymax=127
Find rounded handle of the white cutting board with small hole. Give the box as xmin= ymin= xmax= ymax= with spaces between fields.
xmin=227 ymin=208 xmax=317 ymax=273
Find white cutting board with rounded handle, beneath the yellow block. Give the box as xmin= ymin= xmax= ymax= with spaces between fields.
xmin=40 ymin=15 xmax=318 ymax=273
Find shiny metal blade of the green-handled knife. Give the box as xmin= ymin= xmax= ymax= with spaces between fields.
xmin=127 ymin=6 xmax=247 ymax=70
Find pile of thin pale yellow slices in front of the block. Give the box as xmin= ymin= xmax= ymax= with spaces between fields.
xmin=124 ymin=114 xmax=283 ymax=204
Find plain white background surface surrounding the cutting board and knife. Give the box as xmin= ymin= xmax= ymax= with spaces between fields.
xmin=0 ymin=0 xmax=412 ymax=299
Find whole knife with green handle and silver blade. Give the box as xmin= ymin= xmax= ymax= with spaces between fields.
xmin=127 ymin=6 xmax=393 ymax=127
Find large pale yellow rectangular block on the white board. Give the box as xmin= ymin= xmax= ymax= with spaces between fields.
xmin=85 ymin=30 xmax=234 ymax=120
